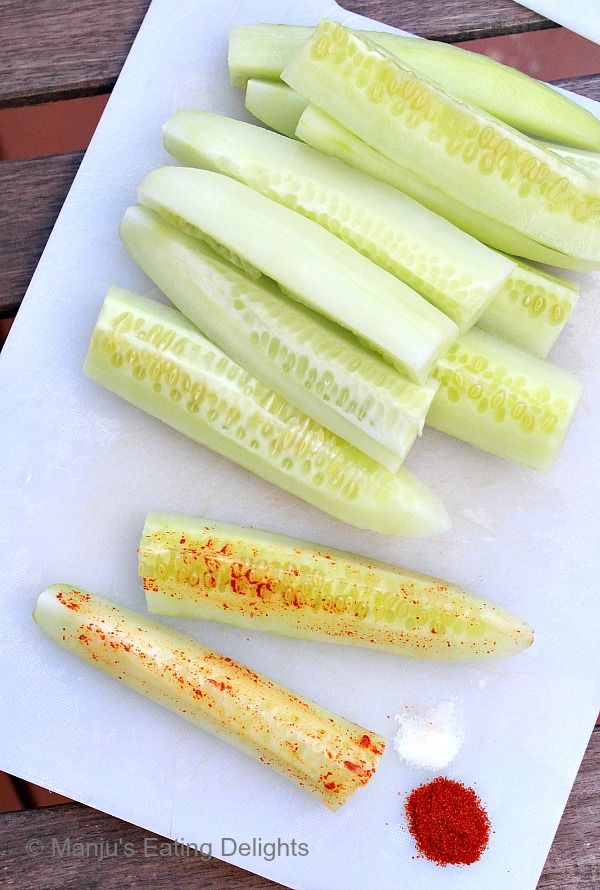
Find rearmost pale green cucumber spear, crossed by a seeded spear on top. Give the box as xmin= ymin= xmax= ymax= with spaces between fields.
xmin=228 ymin=25 xmax=600 ymax=151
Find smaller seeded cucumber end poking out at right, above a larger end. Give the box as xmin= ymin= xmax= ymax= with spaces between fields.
xmin=478 ymin=263 xmax=579 ymax=358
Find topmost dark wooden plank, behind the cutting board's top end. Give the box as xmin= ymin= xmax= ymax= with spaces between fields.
xmin=0 ymin=0 xmax=555 ymax=107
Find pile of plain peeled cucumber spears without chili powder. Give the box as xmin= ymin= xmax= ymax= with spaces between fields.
xmin=86 ymin=21 xmax=600 ymax=536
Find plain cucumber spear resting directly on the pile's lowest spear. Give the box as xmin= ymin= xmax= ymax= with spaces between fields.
xmin=120 ymin=206 xmax=437 ymax=473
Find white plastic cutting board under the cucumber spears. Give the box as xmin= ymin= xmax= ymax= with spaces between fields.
xmin=0 ymin=0 xmax=600 ymax=890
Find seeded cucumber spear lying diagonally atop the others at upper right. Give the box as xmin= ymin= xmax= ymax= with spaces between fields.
xmin=282 ymin=21 xmax=600 ymax=267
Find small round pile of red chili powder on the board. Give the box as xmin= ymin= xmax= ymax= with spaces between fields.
xmin=405 ymin=776 xmax=490 ymax=865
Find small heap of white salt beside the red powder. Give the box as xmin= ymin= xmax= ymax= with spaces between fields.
xmin=394 ymin=701 xmax=465 ymax=770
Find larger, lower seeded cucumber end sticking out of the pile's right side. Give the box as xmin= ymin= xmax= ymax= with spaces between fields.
xmin=427 ymin=328 xmax=581 ymax=470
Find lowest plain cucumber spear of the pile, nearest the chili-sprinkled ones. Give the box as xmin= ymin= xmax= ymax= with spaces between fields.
xmin=84 ymin=287 xmax=449 ymax=537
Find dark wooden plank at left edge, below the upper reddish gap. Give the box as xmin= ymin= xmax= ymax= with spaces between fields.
xmin=0 ymin=152 xmax=83 ymax=317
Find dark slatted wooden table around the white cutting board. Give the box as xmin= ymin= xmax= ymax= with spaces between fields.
xmin=0 ymin=0 xmax=600 ymax=890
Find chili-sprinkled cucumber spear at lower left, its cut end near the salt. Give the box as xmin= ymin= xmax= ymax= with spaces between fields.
xmin=33 ymin=584 xmax=385 ymax=810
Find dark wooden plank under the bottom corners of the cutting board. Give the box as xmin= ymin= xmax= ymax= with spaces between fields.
xmin=0 ymin=730 xmax=600 ymax=890
